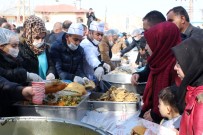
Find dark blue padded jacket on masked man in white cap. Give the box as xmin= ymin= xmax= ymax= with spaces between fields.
xmin=50 ymin=36 xmax=85 ymax=81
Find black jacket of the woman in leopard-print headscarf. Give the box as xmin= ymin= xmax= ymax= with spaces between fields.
xmin=19 ymin=42 xmax=57 ymax=77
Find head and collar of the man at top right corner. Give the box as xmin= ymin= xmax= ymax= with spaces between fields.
xmin=166 ymin=6 xmax=200 ymax=38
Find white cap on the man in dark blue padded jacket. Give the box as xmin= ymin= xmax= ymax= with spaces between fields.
xmin=67 ymin=23 xmax=84 ymax=36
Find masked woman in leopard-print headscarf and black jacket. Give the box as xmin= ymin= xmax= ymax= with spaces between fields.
xmin=19 ymin=15 xmax=55 ymax=80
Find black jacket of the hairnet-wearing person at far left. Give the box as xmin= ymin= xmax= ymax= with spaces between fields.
xmin=0 ymin=51 xmax=27 ymax=84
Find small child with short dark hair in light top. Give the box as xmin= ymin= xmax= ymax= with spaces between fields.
xmin=158 ymin=86 xmax=181 ymax=129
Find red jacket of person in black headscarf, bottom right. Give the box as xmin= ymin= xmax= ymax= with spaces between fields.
xmin=179 ymin=86 xmax=203 ymax=135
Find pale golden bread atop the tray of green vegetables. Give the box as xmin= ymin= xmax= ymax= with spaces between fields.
xmin=64 ymin=82 xmax=87 ymax=96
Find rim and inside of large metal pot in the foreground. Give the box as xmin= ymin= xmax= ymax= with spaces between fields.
xmin=0 ymin=117 xmax=108 ymax=135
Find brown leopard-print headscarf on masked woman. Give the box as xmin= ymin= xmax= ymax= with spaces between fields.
xmin=23 ymin=15 xmax=46 ymax=54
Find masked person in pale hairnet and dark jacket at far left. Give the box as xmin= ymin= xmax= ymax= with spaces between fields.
xmin=0 ymin=28 xmax=42 ymax=85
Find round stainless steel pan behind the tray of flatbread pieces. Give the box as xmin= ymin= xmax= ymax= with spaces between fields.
xmin=101 ymin=74 xmax=146 ymax=95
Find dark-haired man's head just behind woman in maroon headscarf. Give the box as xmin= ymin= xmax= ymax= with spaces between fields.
xmin=142 ymin=10 xmax=166 ymax=30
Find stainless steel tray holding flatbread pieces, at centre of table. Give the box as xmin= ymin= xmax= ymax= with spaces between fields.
xmin=88 ymin=92 xmax=141 ymax=113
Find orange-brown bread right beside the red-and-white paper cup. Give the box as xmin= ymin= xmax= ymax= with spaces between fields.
xmin=45 ymin=79 xmax=67 ymax=94
